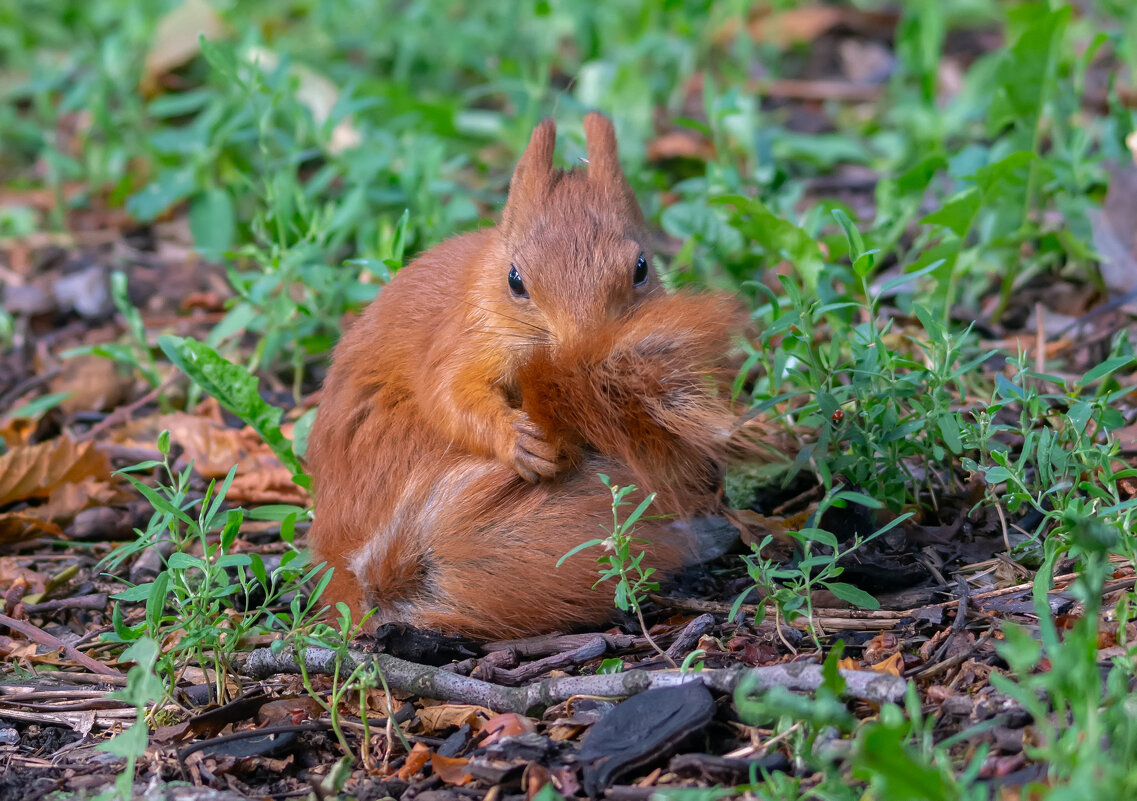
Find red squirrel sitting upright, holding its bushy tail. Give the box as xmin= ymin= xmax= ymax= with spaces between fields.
xmin=308 ymin=114 xmax=746 ymax=638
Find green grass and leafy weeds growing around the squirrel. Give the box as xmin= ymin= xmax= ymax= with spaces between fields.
xmin=0 ymin=0 xmax=1137 ymax=799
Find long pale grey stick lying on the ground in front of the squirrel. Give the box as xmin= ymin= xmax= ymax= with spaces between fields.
xmin=236 ymin=647 xmax=907 ymax=713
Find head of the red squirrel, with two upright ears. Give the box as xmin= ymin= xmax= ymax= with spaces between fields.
xmin=481 ymin=114 xmax=661 ymax=342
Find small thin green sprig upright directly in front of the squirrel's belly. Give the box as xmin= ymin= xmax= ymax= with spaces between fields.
xmin=557 ymin=474 xmax=675 ymax=667
